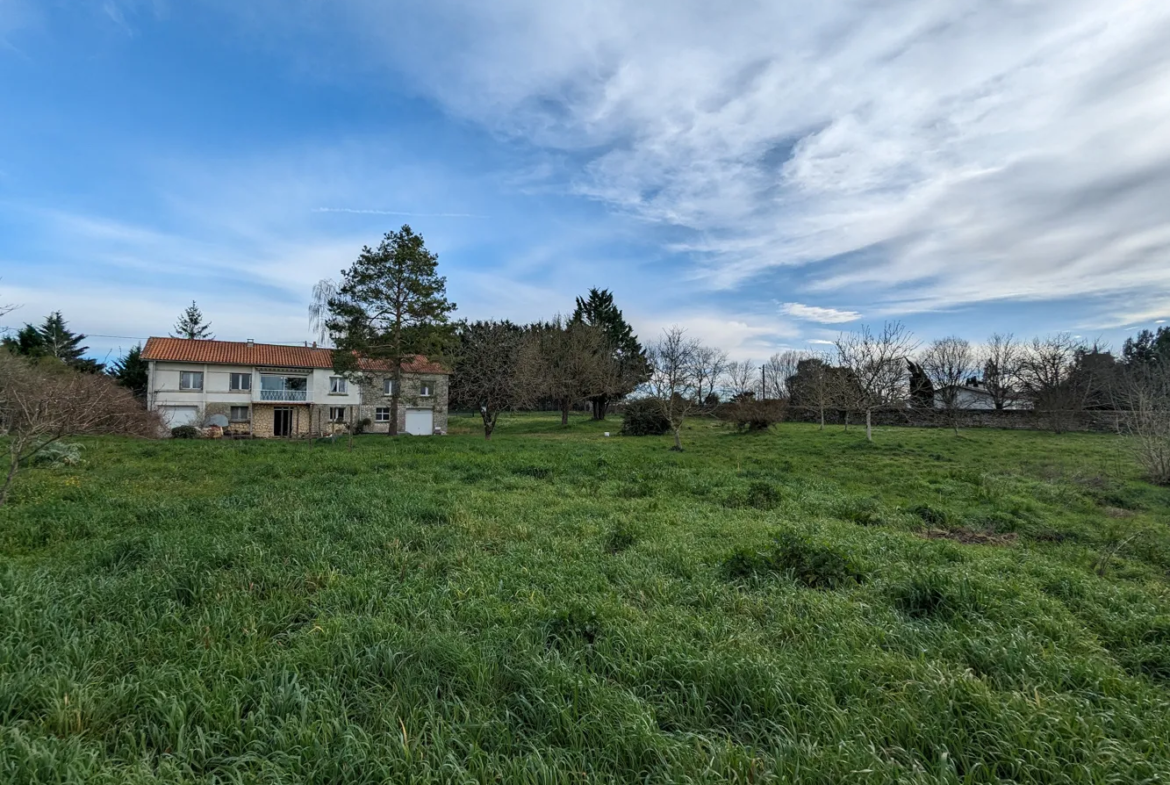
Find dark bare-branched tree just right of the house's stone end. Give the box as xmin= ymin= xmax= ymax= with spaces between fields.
xmin=450 ymin=322 xmax=536 ymax=439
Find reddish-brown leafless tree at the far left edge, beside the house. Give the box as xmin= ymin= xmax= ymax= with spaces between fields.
xmin=0 ymin=351 xmax=163 ymax=505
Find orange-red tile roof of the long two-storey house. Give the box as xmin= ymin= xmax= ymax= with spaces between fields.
xmin=143 ymin=338 xmax=449 ymax=373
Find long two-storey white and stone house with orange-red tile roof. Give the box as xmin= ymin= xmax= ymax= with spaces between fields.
xmin=143 ymin=338 xmax=448 ymax=436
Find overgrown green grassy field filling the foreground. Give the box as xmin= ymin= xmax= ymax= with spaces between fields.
xmin=0 ymin=416 xmax=1170 ymax=784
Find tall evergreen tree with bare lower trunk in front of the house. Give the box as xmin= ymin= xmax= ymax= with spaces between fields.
xmin=314 ymin=223 xmax=455 ymax=436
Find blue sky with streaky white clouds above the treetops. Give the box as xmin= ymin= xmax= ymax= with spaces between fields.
xmin=0 ymin=0 xmax=1170 ymax=361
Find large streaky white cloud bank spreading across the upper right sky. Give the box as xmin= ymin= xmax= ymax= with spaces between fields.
xmin=263 ymin=0 xmax=1170 ymax=311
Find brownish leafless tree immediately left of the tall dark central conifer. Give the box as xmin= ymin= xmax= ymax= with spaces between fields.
xmin=525 ymin=316 xmax=606 ymax=426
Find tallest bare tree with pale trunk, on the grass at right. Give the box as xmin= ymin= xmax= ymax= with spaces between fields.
xmin=835 ymin=322 xmax=917 ymax=441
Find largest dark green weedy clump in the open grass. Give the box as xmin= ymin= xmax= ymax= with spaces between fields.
xmin=723 ymin=532 xmax=866 ymax=590
